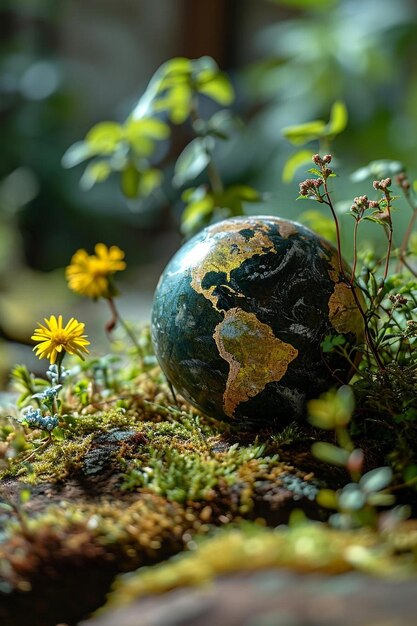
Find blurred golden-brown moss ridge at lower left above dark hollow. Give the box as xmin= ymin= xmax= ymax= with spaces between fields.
xmin=0 ymin=494 xmax=203 ymax=590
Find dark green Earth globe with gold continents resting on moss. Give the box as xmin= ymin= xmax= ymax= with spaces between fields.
xmin=152 ymin=216 xmax=363 ymax=428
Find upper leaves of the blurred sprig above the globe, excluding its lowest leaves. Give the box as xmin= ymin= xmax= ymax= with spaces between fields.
xmin=62 ymin=57 xmax=234 ymax=199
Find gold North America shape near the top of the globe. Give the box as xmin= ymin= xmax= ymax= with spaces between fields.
xmin=191 ymin=222 xmax=276 ymax=310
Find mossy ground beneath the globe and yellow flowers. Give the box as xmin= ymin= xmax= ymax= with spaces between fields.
xmin=0 ymin=346 xmax=417 ymax=626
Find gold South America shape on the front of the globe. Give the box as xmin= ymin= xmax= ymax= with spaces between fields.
xmin=213 ymin=308 xmax=298 ymax=417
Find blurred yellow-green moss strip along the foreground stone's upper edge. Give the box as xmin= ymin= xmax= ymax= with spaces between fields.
xmin=108 ymin=522 xmax=417 ymax=606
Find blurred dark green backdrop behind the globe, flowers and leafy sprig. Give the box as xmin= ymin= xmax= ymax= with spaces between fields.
xmin=0 ymin=0 xmax=417 ymax=379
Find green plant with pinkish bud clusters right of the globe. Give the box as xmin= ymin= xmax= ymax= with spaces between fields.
xmin=299 ymin=154 xmax=417 ymax=372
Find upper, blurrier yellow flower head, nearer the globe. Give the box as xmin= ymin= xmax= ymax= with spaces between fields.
xmin=66 ymin=243 xmax=126 ymax=300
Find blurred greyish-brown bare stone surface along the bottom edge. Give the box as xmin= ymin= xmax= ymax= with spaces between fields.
xmin=80 ymin=570 xmax=417 ymax=626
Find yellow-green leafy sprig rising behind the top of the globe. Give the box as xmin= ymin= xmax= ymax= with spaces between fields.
xmin=63 ymin=57 xmax=261 ymax=236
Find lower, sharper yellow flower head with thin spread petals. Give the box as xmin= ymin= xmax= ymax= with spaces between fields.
xmin=31 ymin=315 xmax=90 ymax=365
